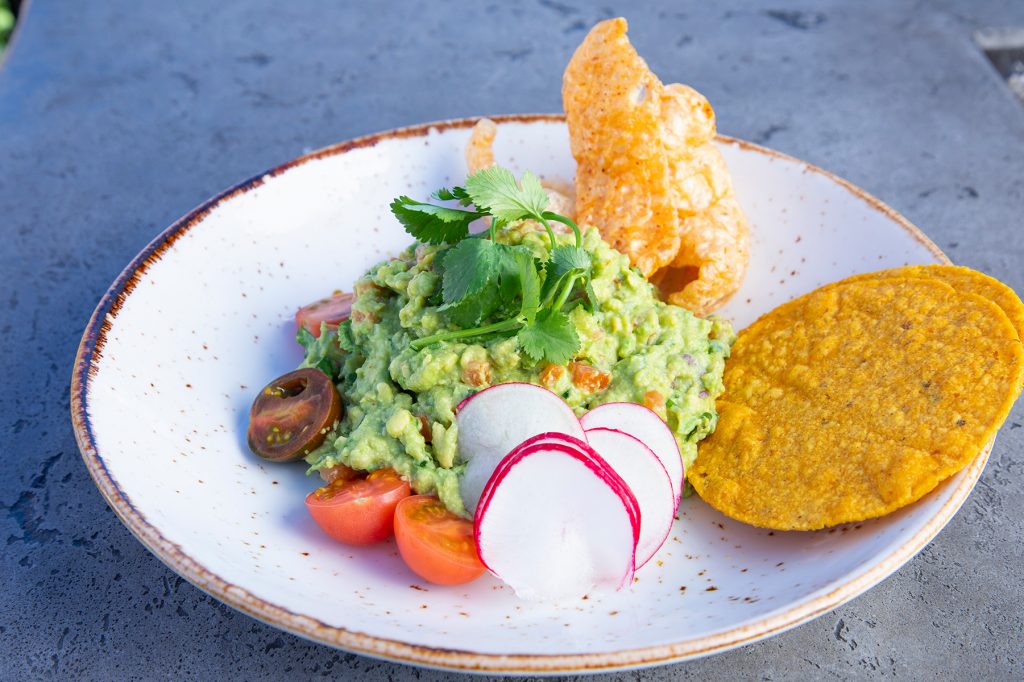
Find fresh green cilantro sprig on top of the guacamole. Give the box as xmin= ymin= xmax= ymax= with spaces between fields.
xmin=391 ymin=166 xmax=596 ymax=365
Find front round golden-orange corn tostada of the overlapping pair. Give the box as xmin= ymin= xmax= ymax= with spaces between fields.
xmin=687 ymin=276 xmax=1024 ymax=530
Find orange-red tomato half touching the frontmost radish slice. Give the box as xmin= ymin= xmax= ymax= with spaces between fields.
xmin=394 ymin=495 xmax=484 ymax=585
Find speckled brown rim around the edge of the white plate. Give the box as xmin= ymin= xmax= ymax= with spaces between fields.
xmin=71 ymin=114 xmax=992 ymax=675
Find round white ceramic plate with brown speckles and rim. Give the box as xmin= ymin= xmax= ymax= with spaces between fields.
xmin=72 ymin=116 xmax=987 ymax=673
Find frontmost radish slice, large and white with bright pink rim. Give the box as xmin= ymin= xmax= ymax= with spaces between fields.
xmin=474 ymin=441 xmax=640 ymax=601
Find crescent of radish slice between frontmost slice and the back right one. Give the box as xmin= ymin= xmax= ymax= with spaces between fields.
xmin=587 ymin=428 xmax=676 ymax=569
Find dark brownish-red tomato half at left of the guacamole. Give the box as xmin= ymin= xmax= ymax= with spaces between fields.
xmin=249 ymin=368 xmax=341 ymax=462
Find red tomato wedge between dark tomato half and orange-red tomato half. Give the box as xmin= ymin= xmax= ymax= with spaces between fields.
xmin=306 ymin=469 xmax=411 ymax=545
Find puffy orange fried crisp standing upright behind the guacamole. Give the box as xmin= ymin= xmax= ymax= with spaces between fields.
xmin=562 ymin=18 xmax=750 ymax=315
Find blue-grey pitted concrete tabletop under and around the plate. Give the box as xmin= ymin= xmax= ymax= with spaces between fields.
xmin=0 ymin=0 xmax=1024 ymax=682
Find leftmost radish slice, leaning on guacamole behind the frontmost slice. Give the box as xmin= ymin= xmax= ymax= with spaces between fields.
xmin=455 ymin=383 xmax=587 ymax=512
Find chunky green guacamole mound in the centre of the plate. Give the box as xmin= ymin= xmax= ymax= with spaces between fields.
xmin=303 ymin=221 xmax=734 ymax=516
